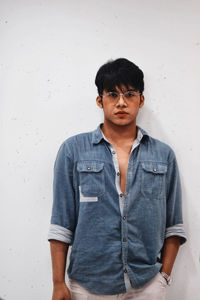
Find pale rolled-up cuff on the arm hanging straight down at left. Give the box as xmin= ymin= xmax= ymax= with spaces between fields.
xmin=48 ymin=224 xmax=74 ymax=245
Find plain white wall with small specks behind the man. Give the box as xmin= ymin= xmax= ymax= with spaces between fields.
xmin=0 ymin=0 xmax=200 ymax=300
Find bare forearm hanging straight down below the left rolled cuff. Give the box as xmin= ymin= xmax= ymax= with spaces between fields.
xmin=50 ymin=240 xmax=69 ymax=284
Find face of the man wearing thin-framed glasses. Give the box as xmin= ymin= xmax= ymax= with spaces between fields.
xmin=96 ymin=85 xmax=144 ymax=126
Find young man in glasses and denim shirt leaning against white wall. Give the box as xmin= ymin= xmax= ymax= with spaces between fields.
xmin=48 ymin=58 xmax=186 ymax=300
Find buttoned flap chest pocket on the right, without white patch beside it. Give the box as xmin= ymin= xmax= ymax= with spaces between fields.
xmin=141 ymin=161 xmax=167 ymax=199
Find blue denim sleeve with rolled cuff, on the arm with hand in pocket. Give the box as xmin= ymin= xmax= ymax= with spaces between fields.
xmin=165 ymin=150 xmax=187 ymax=245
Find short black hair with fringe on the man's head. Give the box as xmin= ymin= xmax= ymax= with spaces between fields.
xmin=95 ymin=58 xmax=144 ymax=95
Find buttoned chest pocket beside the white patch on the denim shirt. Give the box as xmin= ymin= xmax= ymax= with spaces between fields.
xmin=77 ymin=161 xmax=105 ymax=197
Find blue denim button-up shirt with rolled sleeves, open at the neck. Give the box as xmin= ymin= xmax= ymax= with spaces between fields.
xmin=48 ymin=123 xmax=187 ymax=295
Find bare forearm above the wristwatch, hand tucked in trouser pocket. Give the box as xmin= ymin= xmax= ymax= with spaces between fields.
xmin=161 ymin=236 xmax=180 ymax=275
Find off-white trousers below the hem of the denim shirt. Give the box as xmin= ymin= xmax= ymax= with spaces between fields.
xmin=69 ymin=272 xmax=168 ymax=300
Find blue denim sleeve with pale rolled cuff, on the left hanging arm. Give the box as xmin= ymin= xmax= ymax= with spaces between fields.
xmin=48 ymin=142 xmax=76 ymax=245
